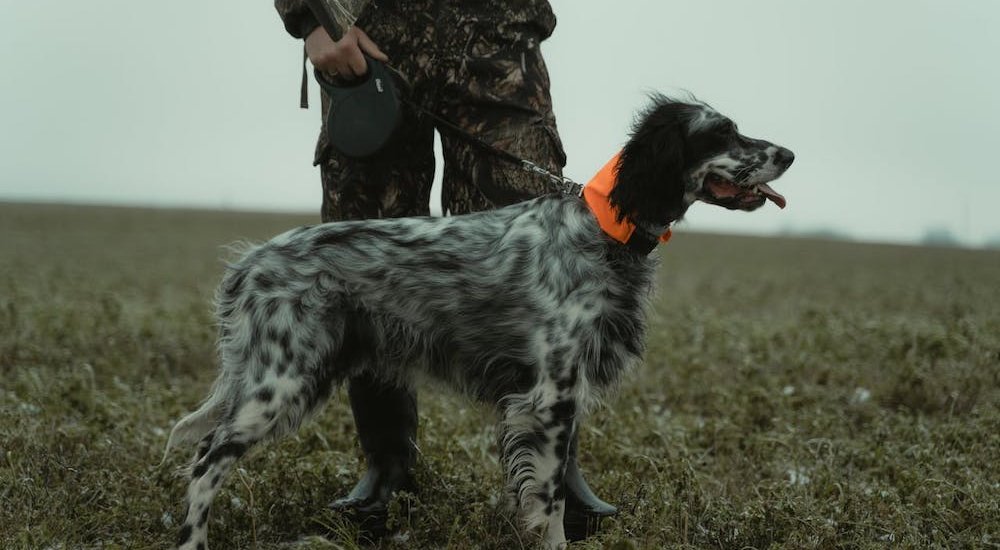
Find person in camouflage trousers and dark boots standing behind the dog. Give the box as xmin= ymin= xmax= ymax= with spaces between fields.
xmin=275 ymin=0 xmax=617 ymax=539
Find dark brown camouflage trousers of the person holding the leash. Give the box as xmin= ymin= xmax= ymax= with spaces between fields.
xmin=315 ymin=0 xmax=566 ymax=221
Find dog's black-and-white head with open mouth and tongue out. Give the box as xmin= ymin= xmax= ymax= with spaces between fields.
xmin=610 ymin=96 xmax=795 ymax=225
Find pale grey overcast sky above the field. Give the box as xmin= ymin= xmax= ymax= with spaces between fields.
xmin=0 ymin=0 xmax=1000 ymax=246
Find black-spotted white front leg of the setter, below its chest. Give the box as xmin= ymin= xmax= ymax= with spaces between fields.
xmin=501 ymin=388 xmax=578 ymax=549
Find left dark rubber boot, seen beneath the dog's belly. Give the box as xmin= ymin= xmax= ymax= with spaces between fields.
xmin=330 ymin=375 xmax=417 ymax=536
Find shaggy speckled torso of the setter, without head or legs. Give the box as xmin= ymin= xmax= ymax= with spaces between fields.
xmin=218 ymin=196 xmax=653 ymax=408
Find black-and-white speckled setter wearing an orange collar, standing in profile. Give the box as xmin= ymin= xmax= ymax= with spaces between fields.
xmin=165 ymin=95 xmax=794 ymax=550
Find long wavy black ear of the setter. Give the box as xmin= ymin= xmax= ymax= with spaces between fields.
xmin=609 ymin=98 xmax=690 ymax=225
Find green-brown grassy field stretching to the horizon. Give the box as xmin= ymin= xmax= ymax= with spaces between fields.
xmin=0 ymin=204 xmax=1000 ymax=549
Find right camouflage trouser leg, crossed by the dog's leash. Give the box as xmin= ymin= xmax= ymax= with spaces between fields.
xmin=436 ymin=0 xmax=566 ymax=214
